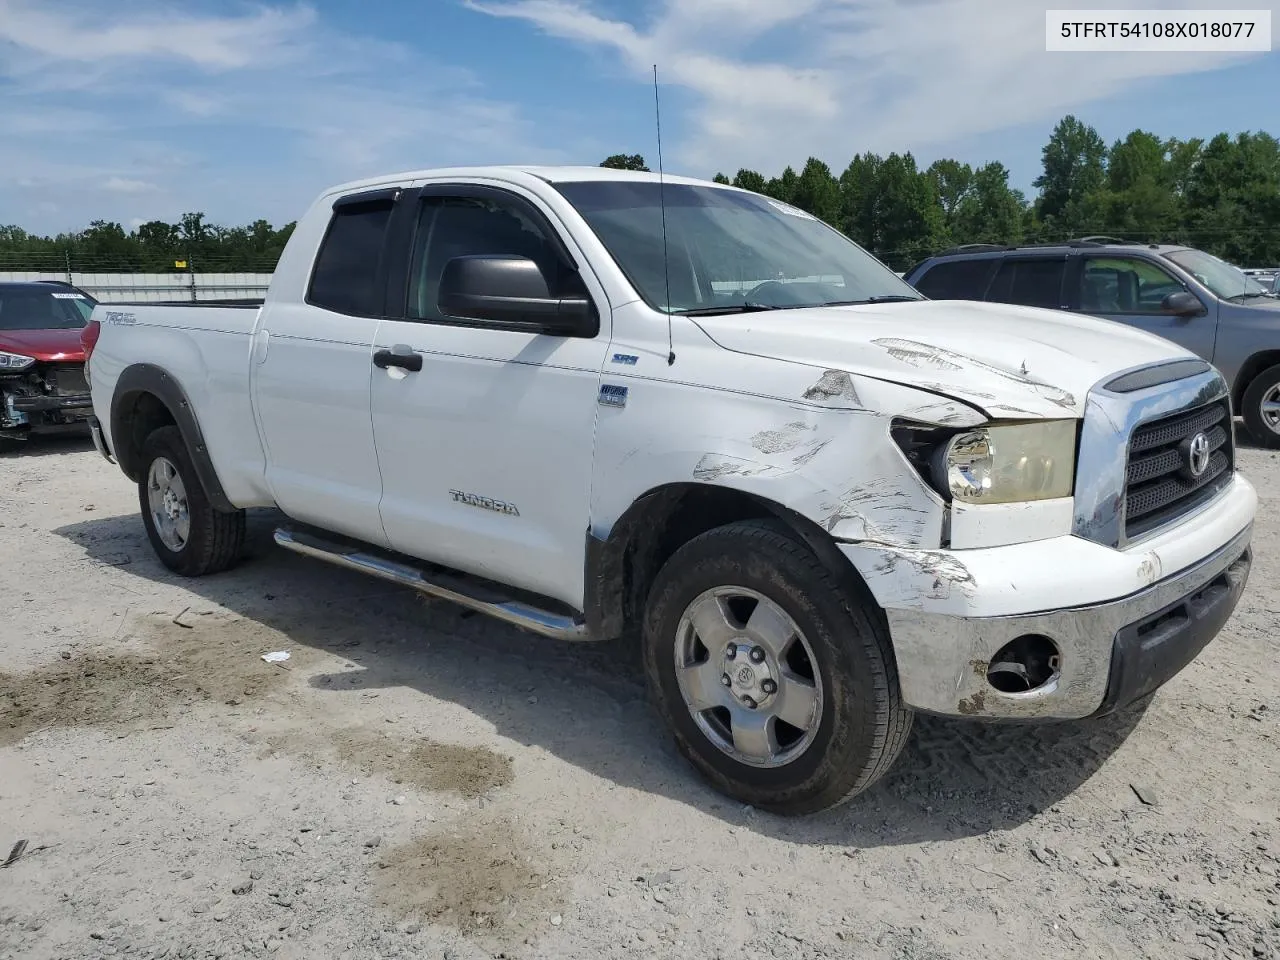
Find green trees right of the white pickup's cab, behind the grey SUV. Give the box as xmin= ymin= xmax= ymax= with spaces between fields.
xmin=602 ymin=115 xmax=1280 ymax=270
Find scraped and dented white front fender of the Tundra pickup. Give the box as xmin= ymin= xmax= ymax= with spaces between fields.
xmin=591 ymin=348 xmax=967 ymax=550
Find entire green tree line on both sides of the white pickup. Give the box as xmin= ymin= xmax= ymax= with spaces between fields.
xmin=0 ymin=116 xmax=1280 ymax=273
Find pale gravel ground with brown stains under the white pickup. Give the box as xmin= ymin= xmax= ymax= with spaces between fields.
xmin=0 ymin=440 xmax=1280 ymax=960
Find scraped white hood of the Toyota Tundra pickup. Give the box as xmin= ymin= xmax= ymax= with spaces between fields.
xmin=696 ymin=300 xmax=1194 ymax=417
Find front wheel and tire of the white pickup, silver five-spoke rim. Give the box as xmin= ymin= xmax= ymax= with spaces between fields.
xmin=643 ymin=520 xmax=913 ymax=814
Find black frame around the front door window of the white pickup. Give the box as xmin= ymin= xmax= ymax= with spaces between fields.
xmin=384 ymin=182 xmax=600 ymax=339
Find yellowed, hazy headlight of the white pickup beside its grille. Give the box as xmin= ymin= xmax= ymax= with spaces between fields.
xmin=934 ymin=420 xmax=1076 ymax=503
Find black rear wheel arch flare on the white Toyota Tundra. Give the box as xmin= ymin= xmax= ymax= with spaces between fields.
xmin=111 ymin=364 xmax=236 ymax=512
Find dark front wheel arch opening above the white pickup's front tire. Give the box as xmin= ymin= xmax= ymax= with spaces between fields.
xmin=584 ymin=483 xmax=883 ymax=640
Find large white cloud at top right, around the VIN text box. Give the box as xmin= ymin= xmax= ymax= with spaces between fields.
xmin=468 ymin=0 xmax=1274 ymax=173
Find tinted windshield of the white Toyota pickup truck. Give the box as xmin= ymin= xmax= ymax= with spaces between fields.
xmin=556 ymin=180 xmax=923 ymax=314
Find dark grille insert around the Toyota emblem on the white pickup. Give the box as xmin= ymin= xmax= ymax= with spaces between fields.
xmin=1125 ymin=399 xmax=1235 ymax=539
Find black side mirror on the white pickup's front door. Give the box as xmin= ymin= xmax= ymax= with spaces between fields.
xmin=438 ymin=255 xmax=599 ymax=337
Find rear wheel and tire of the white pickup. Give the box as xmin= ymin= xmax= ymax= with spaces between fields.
xmin=138 ymin=426 xmax=244 ymax=577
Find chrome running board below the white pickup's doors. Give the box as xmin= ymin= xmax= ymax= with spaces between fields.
xmin=275 ymin=527 xmax=590 ymax=640
